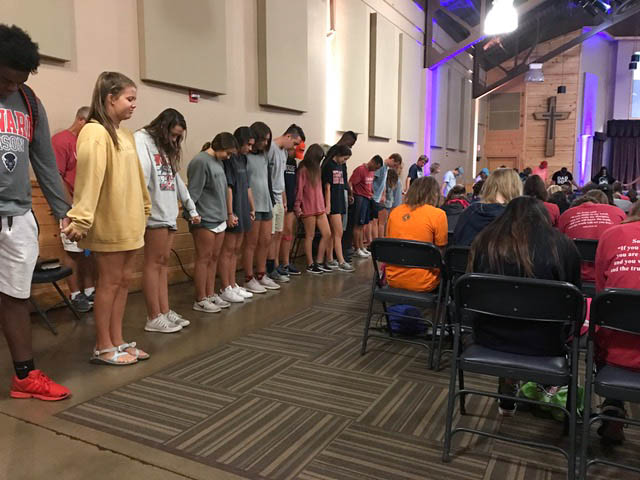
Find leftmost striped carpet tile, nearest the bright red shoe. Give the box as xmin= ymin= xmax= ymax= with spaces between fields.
xmin=59 ymin=377 xmax=236 ymax=444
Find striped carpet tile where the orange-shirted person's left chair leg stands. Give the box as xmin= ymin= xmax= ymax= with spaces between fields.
xmin=313 ymin=334 xmax=420 ymax=377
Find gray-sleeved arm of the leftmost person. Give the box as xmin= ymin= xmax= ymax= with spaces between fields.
xmin=29 ymin=101 xmax=70 ymax=220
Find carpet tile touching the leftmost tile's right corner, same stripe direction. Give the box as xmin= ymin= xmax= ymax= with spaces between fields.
xmin=251 ymin=362 xmax=392 ymax=418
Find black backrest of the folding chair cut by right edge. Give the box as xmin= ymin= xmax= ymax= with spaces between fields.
xmin=589 ymin=288 xmax=640 ymax=335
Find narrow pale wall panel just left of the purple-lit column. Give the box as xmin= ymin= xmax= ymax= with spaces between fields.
xmin=398 ymin=33 xmax=422 ymax=143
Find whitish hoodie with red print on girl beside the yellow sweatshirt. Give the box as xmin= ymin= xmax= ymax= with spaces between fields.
xmin=133 ymin=129 xmax=198 ymax=228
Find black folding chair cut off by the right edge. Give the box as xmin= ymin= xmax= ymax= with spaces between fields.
xmin=580 ymin=289 xmax=640 ymax=479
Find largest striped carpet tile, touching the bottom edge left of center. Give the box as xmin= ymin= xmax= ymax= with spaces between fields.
xmin=165 ymin=395 xmax=350 ymax=480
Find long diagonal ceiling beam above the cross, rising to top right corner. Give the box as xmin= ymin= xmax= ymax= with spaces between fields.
xmin=473 ymin=3 xmax=640 ymax=98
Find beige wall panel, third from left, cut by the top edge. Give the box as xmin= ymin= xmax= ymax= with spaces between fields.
xmin=258 ymin=0 xmax=309 ymax=112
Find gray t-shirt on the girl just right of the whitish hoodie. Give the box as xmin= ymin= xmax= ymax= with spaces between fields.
xmin=187 ymin=152 xmax=229 ymax=226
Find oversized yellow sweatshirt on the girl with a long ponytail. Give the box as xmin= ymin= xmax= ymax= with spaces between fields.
xmin=67 ymin=121 xmax=151 ymax=252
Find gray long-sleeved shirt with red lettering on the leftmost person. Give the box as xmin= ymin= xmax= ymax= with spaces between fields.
xmin=0 ymin=92 xmax=69 ymax=219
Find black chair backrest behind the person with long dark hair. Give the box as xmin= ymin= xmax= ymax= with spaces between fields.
xmin=455 ymin=273 xmax=585 ymax=331
